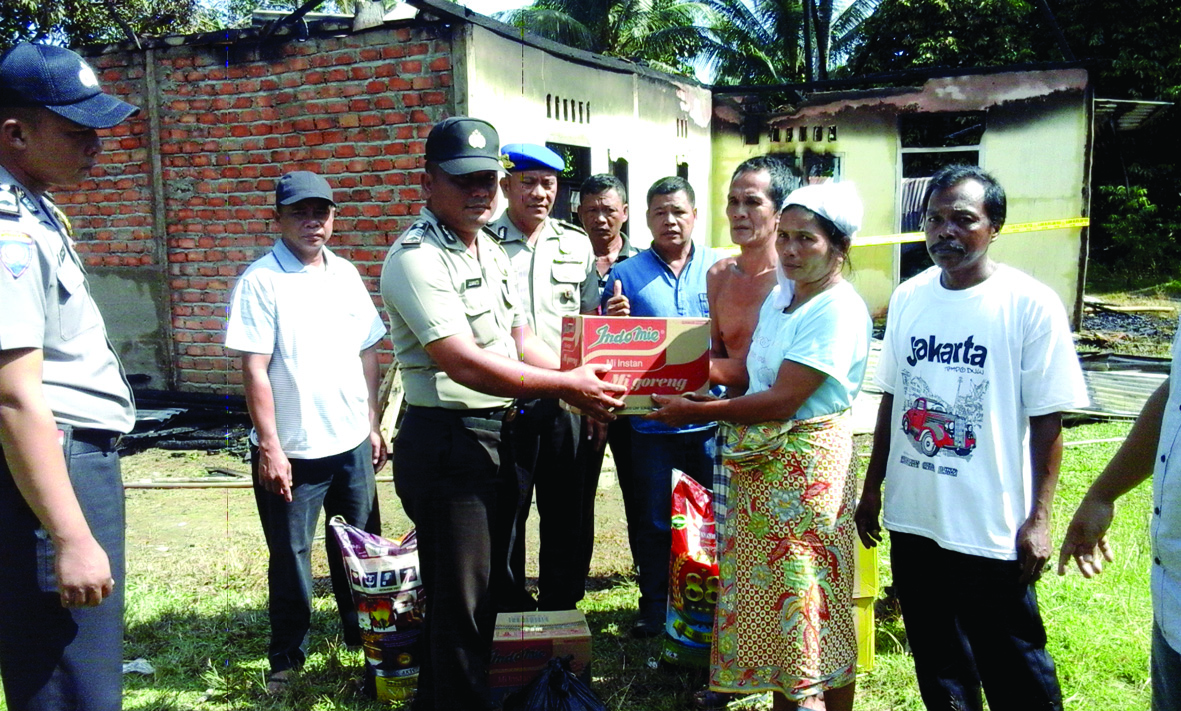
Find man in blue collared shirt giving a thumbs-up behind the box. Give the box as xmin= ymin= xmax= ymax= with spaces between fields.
xmin=602 ymin=177 xmax=720 ymax=638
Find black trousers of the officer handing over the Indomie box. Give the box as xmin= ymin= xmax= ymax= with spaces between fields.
xmin=393 ymin=406 xmax=517 ymax=711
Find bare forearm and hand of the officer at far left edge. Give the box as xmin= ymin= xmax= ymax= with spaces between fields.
xmin=0 ymin=348 xmax=115 ymax=607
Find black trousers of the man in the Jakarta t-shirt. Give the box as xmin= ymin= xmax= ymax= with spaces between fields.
xmin=890 ymin=531 xmax=1062 ymax=711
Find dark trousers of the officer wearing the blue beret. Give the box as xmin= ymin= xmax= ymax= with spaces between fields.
xmin=498 ymin=399 xmax=601 ymax=612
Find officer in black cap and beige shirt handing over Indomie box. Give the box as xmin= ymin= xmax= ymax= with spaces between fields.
xmin=381 ymin=117 xmax=622 ymax=711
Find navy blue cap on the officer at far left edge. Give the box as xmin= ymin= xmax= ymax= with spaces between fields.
xmin=0 ymin=43 xmax=139 ymax=129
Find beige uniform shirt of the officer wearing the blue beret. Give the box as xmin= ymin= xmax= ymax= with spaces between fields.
xmin=488 ymin=213 xmax=599 ymax=353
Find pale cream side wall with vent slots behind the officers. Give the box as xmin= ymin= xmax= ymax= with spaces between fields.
xmin=456 ymin=25 xmax=712 ymax=247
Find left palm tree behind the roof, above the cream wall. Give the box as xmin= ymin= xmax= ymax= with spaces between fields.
xmin=496 ymin=0 xmax=707 ymax=73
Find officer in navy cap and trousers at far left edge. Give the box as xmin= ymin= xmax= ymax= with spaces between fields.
xmin=0 ymin=44 xmax=137 ymax=711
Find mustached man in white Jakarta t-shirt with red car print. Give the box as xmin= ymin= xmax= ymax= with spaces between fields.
xmin=855 ymin=165 xmax=1088 ymax=711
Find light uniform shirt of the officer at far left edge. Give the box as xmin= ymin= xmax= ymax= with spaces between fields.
xmin=0 ymin=167 xmax=136 ymax=432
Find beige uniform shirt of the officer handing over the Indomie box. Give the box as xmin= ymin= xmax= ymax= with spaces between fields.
xmin=381 ymin=208 xmax=526 ymax=410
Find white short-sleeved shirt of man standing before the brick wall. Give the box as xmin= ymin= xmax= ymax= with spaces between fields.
xmin=226 ymin=240 xmax=385 ymax=459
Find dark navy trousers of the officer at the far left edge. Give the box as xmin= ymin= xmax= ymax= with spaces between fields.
xmin=0 ymin=430 xmax=126 ymax=711
